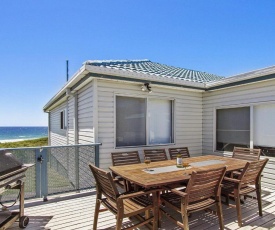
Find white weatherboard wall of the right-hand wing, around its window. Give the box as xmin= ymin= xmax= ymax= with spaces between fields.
xmin=202 ymin=80 xmax=275 ymax=188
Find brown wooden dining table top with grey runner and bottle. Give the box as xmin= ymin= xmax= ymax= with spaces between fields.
xmin=110 ymin=155 xmax=250 ymax=188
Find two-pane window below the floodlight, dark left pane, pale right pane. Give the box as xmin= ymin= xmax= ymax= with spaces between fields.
xmin=116 ymin=96 xmax=173 ymax=147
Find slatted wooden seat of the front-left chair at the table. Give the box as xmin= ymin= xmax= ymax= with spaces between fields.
xmin=102 ymin=196 xmax=153 ymax=217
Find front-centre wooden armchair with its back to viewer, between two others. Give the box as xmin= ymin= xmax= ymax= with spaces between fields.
xmin=160 ymin=167 xmax=226 ymax=230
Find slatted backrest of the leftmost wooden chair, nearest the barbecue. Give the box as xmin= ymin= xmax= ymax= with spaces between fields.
xmin=89 ymin=164 xmax=119 ymax=203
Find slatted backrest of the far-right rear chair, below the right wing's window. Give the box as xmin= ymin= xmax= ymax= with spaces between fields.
xmin=232 ymin=147 xmax=261 ymax=161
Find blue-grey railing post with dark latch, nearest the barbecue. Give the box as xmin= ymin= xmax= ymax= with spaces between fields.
xmin=35 ymin=149 xmax=48 ymax=201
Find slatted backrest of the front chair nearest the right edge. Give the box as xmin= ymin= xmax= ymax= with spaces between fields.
xmin=238 ymin=158 xmax=268 ymax=186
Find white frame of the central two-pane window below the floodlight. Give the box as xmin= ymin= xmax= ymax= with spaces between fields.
xmin=114 ymin=94 xmax=176 ymax=149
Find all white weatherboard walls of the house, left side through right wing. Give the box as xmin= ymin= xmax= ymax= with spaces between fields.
xmin=49 ymin=75 xmax=275 ymax=188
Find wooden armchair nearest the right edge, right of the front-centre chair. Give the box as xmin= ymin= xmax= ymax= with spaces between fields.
xmin=222 ymin=159 xmax=268 ymax=227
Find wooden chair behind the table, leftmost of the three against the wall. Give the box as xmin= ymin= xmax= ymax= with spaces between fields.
xmin=111 ymin=151 xmax=141 ymax=191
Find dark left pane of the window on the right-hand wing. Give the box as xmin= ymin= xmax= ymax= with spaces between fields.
xmin=216 ymin=107 xmax=250 ymax=151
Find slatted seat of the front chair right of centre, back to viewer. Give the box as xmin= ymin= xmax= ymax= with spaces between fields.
xmin=161 ymin=192 xmax=216 ymax=212
